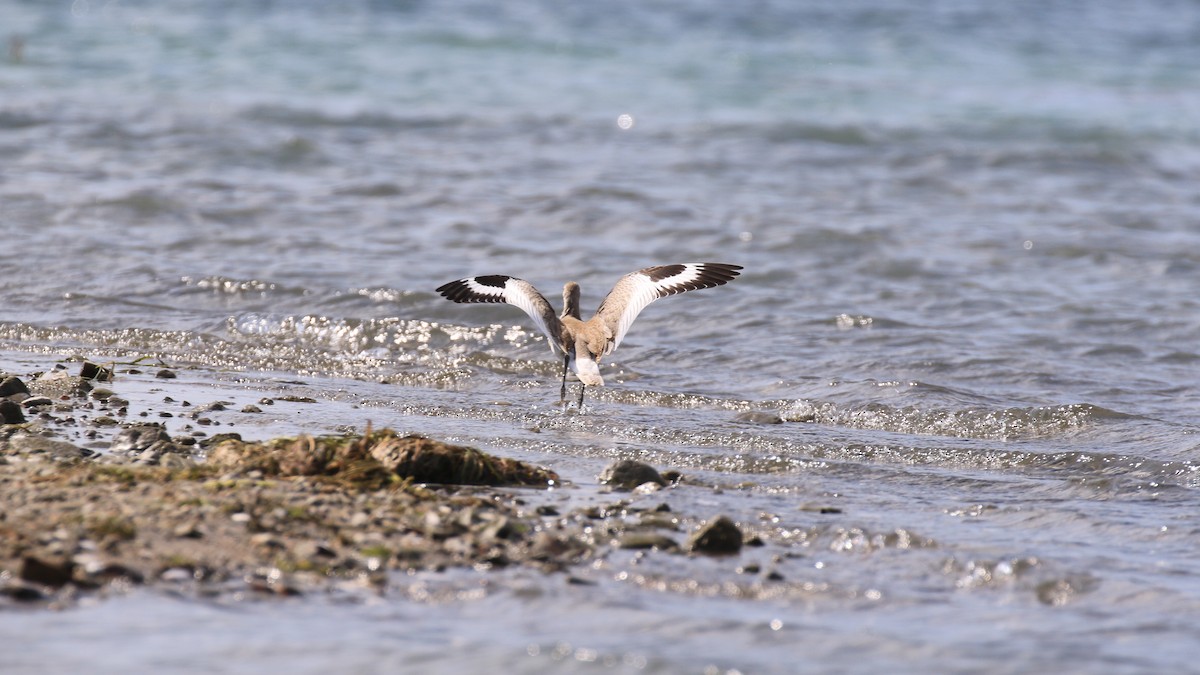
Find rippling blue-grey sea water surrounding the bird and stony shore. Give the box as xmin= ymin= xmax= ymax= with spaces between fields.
xmin=0 ymin=0 xmax=1200 ymax=673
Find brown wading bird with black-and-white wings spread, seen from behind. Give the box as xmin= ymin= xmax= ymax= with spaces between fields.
xmin=438 ymin=263 xmax=742 ymax=407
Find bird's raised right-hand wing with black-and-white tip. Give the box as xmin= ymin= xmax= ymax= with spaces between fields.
xmin=596 ymin=263 xmax=742 ymax=354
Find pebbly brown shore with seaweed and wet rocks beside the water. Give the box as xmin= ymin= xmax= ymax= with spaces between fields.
xmin=0 ymin=362 xmax=763 ymax=608
